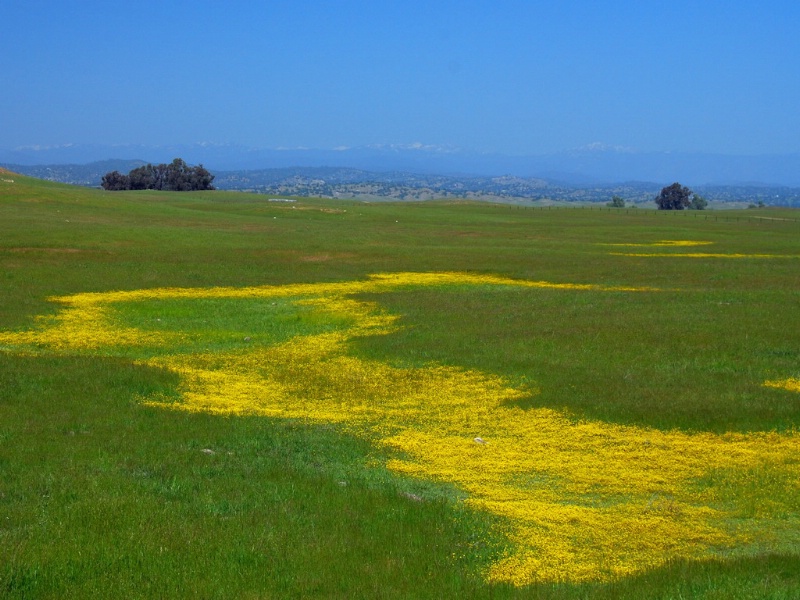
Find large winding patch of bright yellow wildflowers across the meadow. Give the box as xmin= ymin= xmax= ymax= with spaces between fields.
xmin=0 ymin=273 xmax=800 ymax=585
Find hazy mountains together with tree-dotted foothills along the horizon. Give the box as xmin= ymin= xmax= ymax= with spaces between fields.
xmin=0 ymin=144 xmax=800 ymax=206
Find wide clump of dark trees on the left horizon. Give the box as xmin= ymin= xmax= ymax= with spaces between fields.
xmin=100 ymin=158 xmax=214 ymax=192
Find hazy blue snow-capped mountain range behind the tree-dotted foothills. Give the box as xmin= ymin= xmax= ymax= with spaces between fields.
xmin=0 ymin=144 xmax=800 ymax=188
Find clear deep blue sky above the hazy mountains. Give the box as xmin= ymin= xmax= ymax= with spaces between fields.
xmin=0 ymin=0 xmax=800 ymax=154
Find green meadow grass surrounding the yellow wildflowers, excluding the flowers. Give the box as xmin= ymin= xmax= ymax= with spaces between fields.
xmin=0 ymin=176 xmax=800 ymax=598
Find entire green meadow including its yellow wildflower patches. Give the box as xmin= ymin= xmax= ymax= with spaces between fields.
xmin=0 ymin=172 xmax=800 ymax=600
